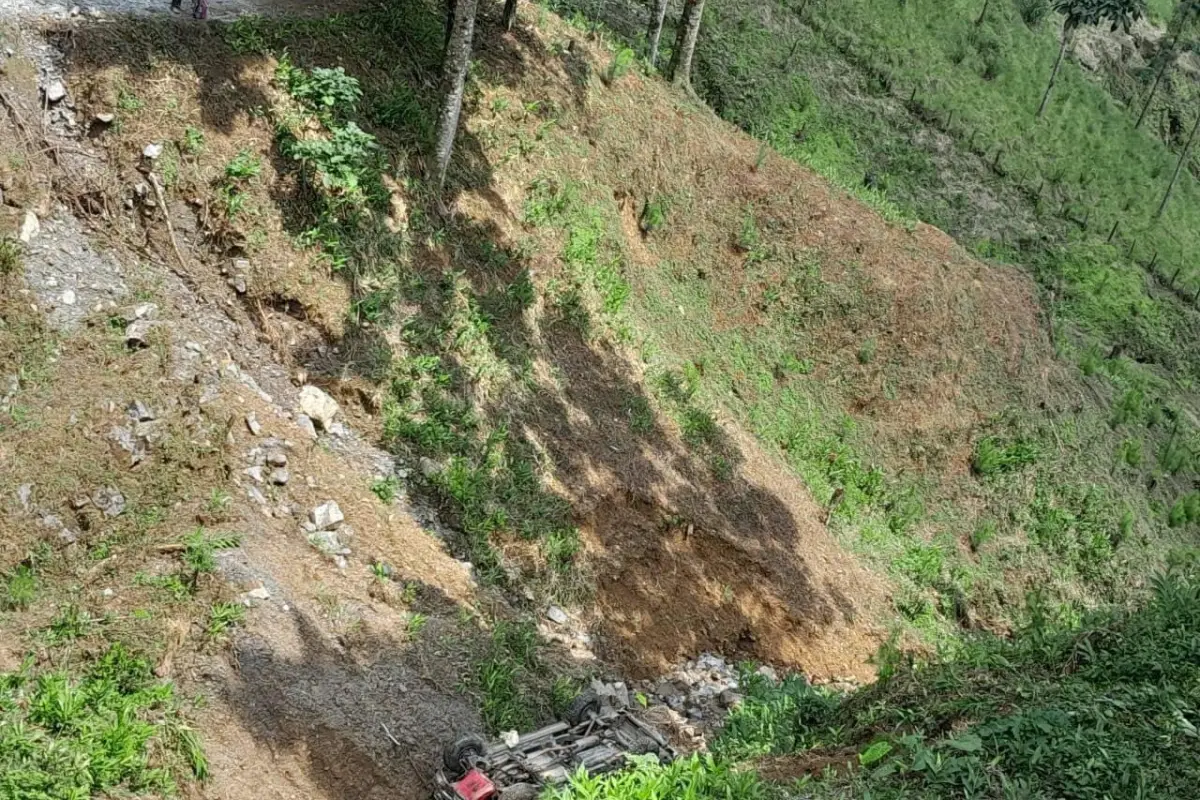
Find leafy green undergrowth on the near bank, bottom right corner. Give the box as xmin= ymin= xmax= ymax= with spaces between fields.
xmin=557 ymin=560 xmax=1200 ymax=800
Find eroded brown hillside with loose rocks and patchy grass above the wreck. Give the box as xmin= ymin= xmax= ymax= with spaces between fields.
xmin=0 ymin=2 xmax=1182 ymax=798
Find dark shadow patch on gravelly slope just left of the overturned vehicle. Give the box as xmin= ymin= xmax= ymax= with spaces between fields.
xmin=218 ymin=587 xmax=479 ymax=800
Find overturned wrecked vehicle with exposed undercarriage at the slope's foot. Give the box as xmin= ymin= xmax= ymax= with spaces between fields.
xmin=433 ymin=692 xmax=676 ymax=800
